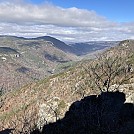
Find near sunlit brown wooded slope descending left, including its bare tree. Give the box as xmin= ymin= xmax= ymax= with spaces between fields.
xmin=0 ymin=40 xmax=134 ymax=132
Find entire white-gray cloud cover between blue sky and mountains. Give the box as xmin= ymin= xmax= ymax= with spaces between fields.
xmin=0 ymin=0 xmax=134 ymax=42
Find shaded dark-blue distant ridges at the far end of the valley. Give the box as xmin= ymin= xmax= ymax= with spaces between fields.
xmin=36 ymin=36 xmax=118 ymax=56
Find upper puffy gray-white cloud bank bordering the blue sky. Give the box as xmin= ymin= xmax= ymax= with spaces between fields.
xmin=0 ymin=2 xmax=113 ymax=27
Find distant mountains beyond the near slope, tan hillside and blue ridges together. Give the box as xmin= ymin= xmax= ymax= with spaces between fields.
xmin=0 ymin=36 xmax=118 ymax=90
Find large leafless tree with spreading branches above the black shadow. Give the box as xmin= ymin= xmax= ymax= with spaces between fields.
xmin=84 ymin=53 xmax=132 ymax=92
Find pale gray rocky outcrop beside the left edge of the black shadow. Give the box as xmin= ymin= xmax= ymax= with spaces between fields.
xmin=37 ymin=97 xmax=68 ymax=129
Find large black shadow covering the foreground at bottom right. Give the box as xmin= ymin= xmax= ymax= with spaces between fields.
xmin=42 ymin=91 xmax=134 ymax=134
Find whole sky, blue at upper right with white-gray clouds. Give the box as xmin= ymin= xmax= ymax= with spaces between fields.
xmin=0 ymin=0 xmax=134 ymax=42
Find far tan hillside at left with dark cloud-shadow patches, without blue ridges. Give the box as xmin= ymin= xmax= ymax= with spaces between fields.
xmin=0 ymin=36 xmax=76 ymax=90
